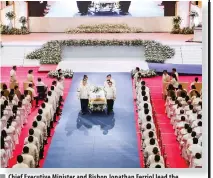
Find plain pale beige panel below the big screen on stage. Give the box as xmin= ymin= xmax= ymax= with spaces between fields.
xmin=29 ymin=17 xmax=173 ymax=32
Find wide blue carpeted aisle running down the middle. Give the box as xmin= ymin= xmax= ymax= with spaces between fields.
xmin=44 ymin=73 xmax=140 ymax=168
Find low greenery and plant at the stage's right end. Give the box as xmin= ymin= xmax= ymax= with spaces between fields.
xmin=171 ymin=16 xmax=194 ymax=34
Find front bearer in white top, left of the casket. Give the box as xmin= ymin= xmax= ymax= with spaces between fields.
xmin=78 ymin=79 xmax=90 ymax=115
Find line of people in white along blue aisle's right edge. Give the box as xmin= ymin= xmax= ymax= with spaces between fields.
xmin=135 ymin=77 xmax=165 ymax=168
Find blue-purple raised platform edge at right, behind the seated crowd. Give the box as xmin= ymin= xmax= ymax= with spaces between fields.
xmin=148 ymin=63 xmax=202 ymax=75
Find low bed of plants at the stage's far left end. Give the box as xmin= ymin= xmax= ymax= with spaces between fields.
xmin=0 ymin=25 xmax=30 ymax=35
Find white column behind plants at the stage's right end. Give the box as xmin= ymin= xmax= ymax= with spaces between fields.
xmin=177 ymin=1 xmax=190 ymax=28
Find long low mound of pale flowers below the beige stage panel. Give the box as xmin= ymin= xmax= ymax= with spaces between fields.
xmin=65 ymin=24 xmax=143 ymax=33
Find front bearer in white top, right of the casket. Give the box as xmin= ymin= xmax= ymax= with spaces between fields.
xmin=105 ymin=81 xmax=116 ymax=115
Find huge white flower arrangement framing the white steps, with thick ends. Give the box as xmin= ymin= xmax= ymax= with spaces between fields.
xmin=26 ymin=39 xmax=175 ymax=64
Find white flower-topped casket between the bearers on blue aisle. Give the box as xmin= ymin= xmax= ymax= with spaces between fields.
xmin=89 ymin=87 xmax=107 ymax=111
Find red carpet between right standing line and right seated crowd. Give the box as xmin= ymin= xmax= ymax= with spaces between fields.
xmin=144 ymin=76 xmax=202 ymax=168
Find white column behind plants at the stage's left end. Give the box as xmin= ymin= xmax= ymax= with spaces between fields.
xmin=14 ymin=1 xmax=28 ymax=28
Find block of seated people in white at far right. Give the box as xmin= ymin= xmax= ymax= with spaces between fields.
xmin=165 ymin=85 xmax=202 ymax=167
